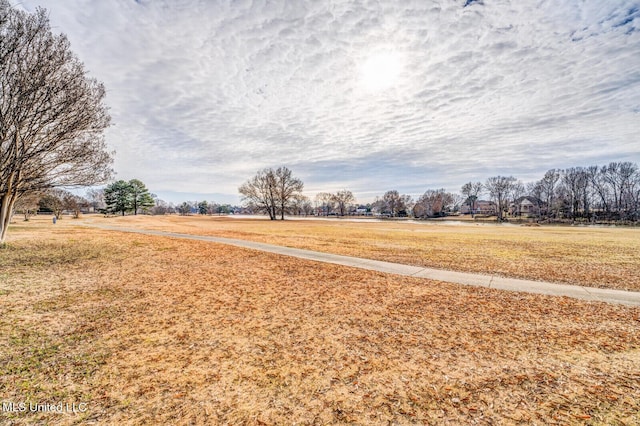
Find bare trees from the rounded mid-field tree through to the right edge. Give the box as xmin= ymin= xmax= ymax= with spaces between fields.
xmin=240 ymin=162 xmax=640 ymax=221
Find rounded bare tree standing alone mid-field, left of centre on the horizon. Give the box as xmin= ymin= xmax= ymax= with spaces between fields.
xmin=238 ymin=167 xmax=304 ymax=220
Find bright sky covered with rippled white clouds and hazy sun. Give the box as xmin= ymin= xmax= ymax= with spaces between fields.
xmin=12 ymin=0 xmax=640 ymax=204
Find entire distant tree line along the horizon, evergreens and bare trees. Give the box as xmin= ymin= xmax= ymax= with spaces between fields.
xmin=14 ymin=162 xmax=640 ymax=222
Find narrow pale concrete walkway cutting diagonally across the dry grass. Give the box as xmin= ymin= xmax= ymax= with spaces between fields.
xmin=85 ymin=224 xmax=640 ymax=306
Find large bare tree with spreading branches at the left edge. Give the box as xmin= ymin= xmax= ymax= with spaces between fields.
xmin=0 ymin=0 xmax=112 ymax=242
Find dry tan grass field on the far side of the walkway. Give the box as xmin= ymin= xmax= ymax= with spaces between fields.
xmin=82 ymin=216 xmax=640 ymax=290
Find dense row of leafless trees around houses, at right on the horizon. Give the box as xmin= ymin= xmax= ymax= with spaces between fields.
xmin=364 ymin=162 xmax=640 ymax=221
